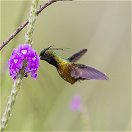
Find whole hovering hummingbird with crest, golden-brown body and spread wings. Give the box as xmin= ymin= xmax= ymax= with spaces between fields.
xmin=39 ymin=46 xmax=108 ymax=84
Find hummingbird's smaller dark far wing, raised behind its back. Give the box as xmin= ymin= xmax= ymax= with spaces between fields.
xmin=68 ymin=49 xmax=87 ymax=62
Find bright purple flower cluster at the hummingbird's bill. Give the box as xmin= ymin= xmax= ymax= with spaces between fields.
xmin=8 ymin=44 xmax=40 ymax=80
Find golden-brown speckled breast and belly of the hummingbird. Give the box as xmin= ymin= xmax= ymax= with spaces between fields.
xmin=57 ymin=60 xmax=77 ymax=84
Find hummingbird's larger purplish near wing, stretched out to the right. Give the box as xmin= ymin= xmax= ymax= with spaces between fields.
xmin=71 ymin=64 xmax=108 ymax=80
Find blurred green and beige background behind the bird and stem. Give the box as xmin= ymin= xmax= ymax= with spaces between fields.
xmin=0 ymin=1 xmax=131 ymax=131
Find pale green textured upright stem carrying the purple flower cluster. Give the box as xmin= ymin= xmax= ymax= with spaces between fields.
xmin=1 ymin=0 xmax=39 ymax=132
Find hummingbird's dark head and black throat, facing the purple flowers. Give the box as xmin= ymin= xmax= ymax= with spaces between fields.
xmin=39 ymin=46 xmax=57 ymax=67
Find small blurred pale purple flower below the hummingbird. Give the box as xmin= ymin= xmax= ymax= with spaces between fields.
xmin=70 ymin=95 xmax=81 ymax=111
